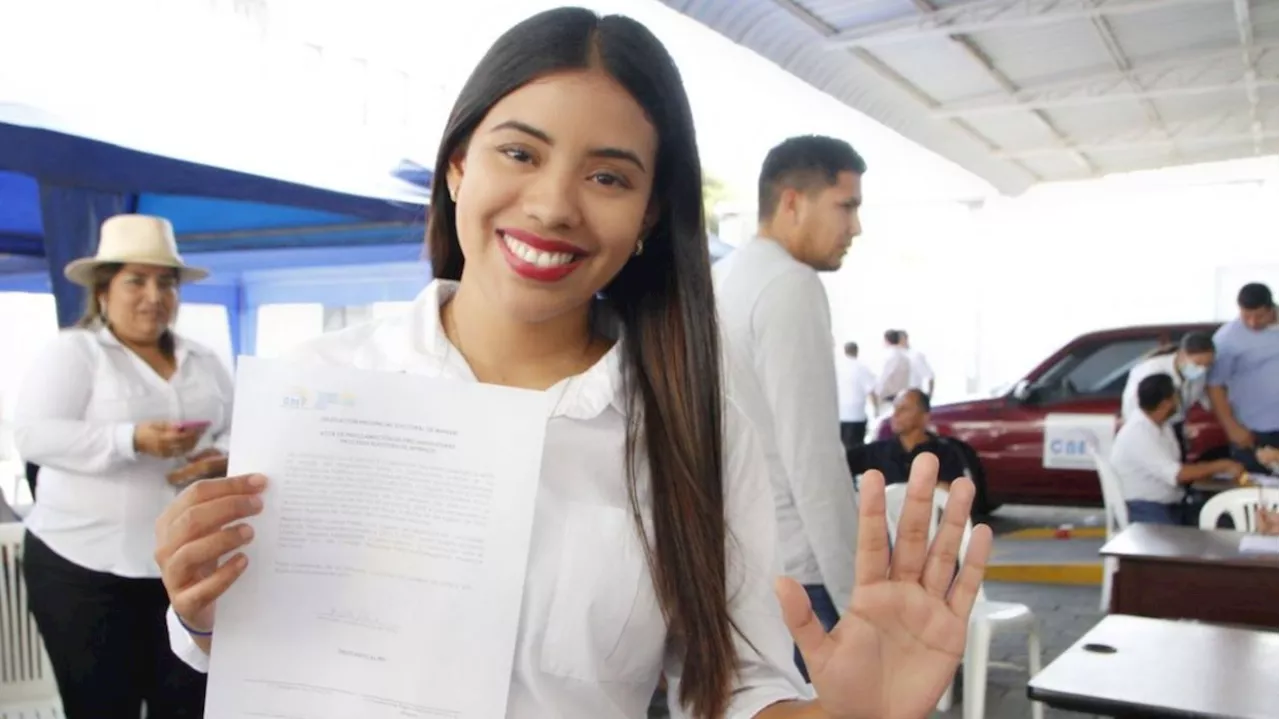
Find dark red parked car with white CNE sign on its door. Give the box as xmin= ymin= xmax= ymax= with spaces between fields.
xmin=876 ymin=322 xmax=1228 ymax=513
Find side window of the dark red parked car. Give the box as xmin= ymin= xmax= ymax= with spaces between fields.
xmin=1036 ymin=336 xmax=1161 ymax=400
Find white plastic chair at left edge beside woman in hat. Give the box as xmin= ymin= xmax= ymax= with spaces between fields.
xmin=0 ymin=522 xmax=63 ymax=719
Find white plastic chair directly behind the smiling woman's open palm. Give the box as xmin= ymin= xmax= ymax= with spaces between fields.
xmin=884 ymin=484 xmax=1044 ymax=719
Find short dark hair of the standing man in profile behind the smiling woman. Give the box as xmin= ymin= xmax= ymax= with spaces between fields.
xmin=759 ymin=134 xmax=867 ymax=220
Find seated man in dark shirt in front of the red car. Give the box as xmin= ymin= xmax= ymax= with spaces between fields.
xmin=849 ymin=389 xmax=965 ymax=487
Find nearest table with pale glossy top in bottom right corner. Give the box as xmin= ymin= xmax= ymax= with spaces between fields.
xmin=1027 ymin=614 xmax=1280 ymax=719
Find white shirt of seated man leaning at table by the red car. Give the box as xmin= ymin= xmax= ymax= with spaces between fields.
xmin=1111 ymin=412 xmax=1184 ymax=504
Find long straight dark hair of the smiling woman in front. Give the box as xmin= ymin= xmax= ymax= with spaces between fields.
xmin=428 ymin=8 xmax=737 ymax=719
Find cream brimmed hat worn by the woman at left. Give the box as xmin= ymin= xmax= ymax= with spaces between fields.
xmin=63 ymin=215 xmax=209 ymax=287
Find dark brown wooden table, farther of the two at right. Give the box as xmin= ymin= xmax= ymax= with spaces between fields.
xmin=1100 ymin=523 xmax=1280 ymax=626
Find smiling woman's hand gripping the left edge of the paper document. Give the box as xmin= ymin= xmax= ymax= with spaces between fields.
xmin=156 ymin=475 xmax=266 ymax=631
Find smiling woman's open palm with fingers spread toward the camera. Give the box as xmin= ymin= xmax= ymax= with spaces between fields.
xmin=778 ymin=454 xmax=991 ymax=719
